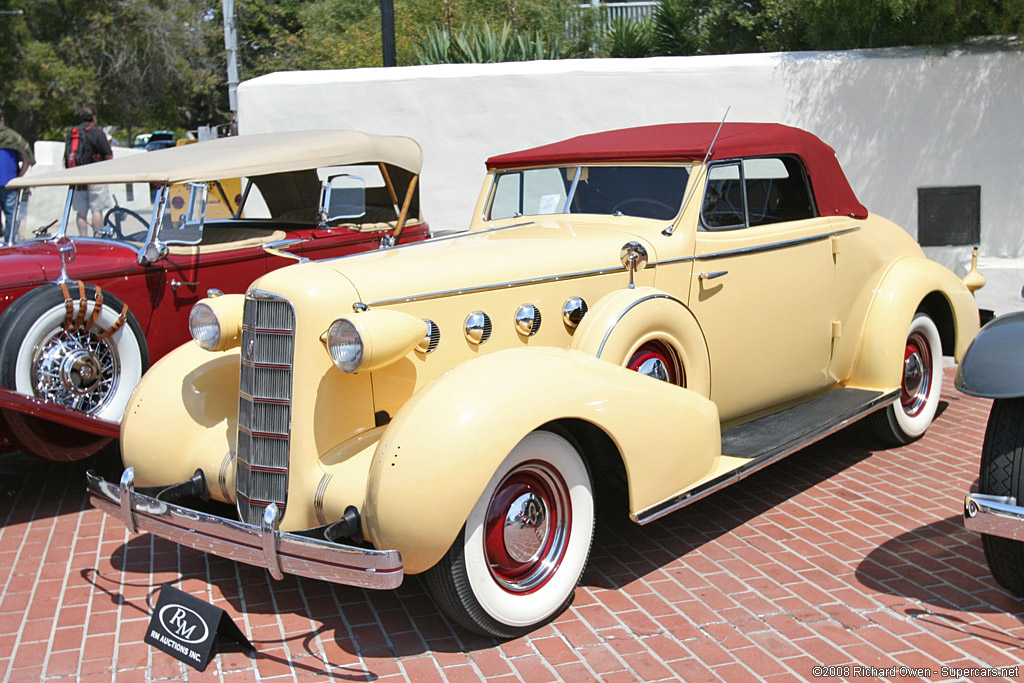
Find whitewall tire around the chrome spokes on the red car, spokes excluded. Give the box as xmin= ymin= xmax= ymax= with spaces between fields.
xmin=0 ymin=285 xmax=150 ymax=422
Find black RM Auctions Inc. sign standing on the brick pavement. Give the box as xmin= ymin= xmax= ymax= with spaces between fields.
xmin=145 ymin=586 xmax=253 ymax=671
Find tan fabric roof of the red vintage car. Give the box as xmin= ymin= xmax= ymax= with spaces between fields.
xmin=7 ymin=130 xmax=423 ymax=187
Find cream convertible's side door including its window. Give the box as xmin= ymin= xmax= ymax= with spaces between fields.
xmin=689 ymin=157 xmax=836 ymax=422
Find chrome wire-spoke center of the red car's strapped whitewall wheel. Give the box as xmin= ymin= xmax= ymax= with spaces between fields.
xmin=32 ymin=328 xmax=120 ymax=413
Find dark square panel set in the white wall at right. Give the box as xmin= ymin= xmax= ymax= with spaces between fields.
xmin=918 ymin=185 xmax=981 ymax=247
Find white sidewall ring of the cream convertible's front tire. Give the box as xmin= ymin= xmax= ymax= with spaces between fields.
xmin=462 ymin=431 xmax=594 ymax=628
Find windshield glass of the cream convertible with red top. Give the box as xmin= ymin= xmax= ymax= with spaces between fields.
xmin=488 ymin=166 xmax=690 ymax=220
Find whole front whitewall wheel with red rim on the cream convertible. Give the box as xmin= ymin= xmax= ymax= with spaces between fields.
xmin=426 ymin=431 xmax=594 ymax=638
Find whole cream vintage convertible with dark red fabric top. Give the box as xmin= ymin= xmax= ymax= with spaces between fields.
xmin=88 ymin=123 xmax=978 ymax=637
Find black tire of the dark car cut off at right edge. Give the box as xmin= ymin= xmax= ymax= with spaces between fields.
xmin=978 ymin=398 xmax=1024 ymax=596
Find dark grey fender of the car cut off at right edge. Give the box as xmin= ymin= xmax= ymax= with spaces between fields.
xmin=954 ymin=311 xmax=1024 ymax=398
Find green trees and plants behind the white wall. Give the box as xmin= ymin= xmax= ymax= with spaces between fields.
xmin=0 ymin=0 xmax=1024 ymax=144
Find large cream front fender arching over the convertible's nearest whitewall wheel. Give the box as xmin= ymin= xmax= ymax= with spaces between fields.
xmin=364 ymin=348 xmax=721 ymax=573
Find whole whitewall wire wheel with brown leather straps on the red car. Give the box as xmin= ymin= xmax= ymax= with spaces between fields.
xmin=0 ymin=283 xmax=150 ymax=461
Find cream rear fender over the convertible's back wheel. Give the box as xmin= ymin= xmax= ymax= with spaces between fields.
xmin=847 ymin=257 xmax=978 ymax=389
